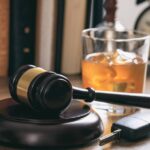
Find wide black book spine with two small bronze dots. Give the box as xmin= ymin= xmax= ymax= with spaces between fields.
xmin=9 ymin=0 xmax=36 ymax=76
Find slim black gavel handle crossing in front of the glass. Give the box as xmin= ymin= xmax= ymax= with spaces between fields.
xmin=73 ymin=87 xmax=150 ymax=108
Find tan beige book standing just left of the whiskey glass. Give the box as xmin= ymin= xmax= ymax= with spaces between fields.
xmin=61 ymin=0 xmax=86 ymax=74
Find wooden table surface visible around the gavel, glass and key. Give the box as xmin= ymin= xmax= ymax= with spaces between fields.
xmin=0 ymin=76 xmax=150 ymax=150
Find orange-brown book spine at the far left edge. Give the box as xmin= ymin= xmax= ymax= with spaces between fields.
xmin=0 ymin=0 xmax=9 ymax=76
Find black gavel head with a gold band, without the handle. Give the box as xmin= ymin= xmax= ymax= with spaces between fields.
xmin=9 ymin=65 xmax=72 ymax=114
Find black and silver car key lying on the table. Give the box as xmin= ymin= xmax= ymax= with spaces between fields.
xmin=100 ymin=112 xmax=150 ymax=145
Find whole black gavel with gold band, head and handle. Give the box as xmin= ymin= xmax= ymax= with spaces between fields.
xmin=9 ymin=65 xmax=150 ymax=114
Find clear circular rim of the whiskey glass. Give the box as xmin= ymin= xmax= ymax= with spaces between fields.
xmin=82 ymin=28 xmax=150 ymax=42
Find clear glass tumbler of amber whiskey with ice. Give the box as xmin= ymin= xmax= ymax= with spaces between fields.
xmin=82 ymin=28 xmax=150 ymax=115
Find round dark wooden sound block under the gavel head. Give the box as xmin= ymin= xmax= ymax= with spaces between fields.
xmin=0 ymin=99 xmax=103 ymax=148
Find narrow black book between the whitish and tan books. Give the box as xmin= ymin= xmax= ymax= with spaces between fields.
xmin=54 ymin=0 xmax=65 ymax=73
